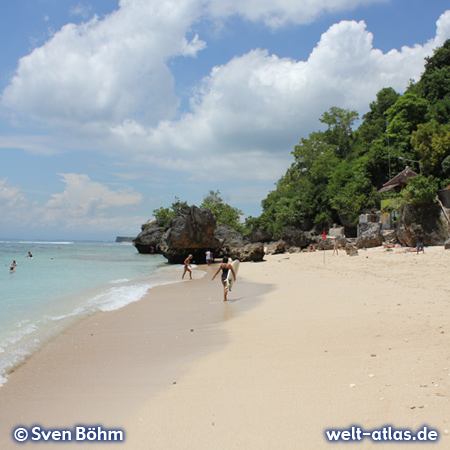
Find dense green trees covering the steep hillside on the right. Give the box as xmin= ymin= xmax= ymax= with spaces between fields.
xmin=246 ymin=40 xmax=450 ymax=236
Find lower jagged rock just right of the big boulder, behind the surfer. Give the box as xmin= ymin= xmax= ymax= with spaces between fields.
xmin=214 ymin=225 xmax=264 ymax=262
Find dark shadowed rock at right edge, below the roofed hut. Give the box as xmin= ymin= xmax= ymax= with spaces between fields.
xmin=397 ymin=205 xmax=449 ymax=247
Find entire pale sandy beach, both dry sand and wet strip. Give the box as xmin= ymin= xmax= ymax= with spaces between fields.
xmin=0 ymin=247 xmax=450 ymax=450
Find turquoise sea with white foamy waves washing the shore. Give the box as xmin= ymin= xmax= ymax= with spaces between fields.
xmin=0 ymin=241 xmax=186 ymax=386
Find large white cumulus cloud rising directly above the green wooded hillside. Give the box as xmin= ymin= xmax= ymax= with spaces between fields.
xmin=103 ymin=11 xmax=450 ymax=180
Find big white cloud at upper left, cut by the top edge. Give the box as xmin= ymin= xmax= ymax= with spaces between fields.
xmin=2 ymin=0 xmax=204 ymax=131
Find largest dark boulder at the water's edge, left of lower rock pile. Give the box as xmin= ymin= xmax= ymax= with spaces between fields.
xmin=159 ymin=206 xmax=221 ymax=264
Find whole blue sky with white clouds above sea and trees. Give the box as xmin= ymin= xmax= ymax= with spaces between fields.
xmin=0 ymin=0 xmax=450 ymax=240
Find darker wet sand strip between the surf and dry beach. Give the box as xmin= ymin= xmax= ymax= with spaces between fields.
xmin=0 ymin=265 xmax=268 ymax=448
